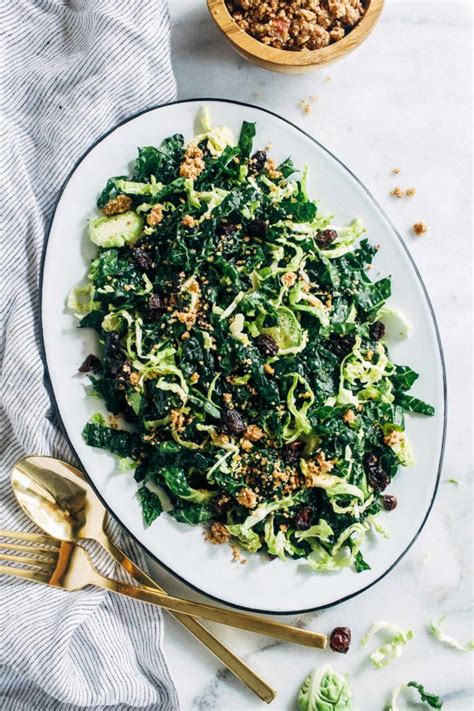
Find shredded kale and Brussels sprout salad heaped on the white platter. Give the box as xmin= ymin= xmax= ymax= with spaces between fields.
xmin=68 ymin=110 xmax=434 ymax=572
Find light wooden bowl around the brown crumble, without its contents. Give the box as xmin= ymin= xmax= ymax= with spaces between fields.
xmin=207 ymin=0 xmax=384 ymax=74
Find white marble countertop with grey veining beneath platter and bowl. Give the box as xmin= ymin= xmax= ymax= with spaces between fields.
xmin=146 ymin=0 xmax=474 ymax=711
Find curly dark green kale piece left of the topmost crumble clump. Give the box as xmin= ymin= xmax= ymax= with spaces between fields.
xmin=132 ymin=133 xmax=184 ymax=183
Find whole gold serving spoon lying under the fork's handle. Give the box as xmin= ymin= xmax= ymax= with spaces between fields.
xmin=11 ymin=456 xmax=276 ymax=703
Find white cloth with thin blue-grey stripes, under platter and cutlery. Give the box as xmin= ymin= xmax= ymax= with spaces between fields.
xmin=0 ymin=0 xmax=179 ymax=711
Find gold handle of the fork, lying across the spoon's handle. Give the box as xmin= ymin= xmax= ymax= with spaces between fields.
xmin=102 ymin=578 xmax=327 ymax=649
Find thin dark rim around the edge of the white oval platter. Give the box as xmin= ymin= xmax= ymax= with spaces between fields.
xmin=40 ymin=97 xmax=447 ymax=615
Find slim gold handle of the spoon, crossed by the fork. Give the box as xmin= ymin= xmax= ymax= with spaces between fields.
xmin=100 ymin=534 xmax=276 ymax=704
